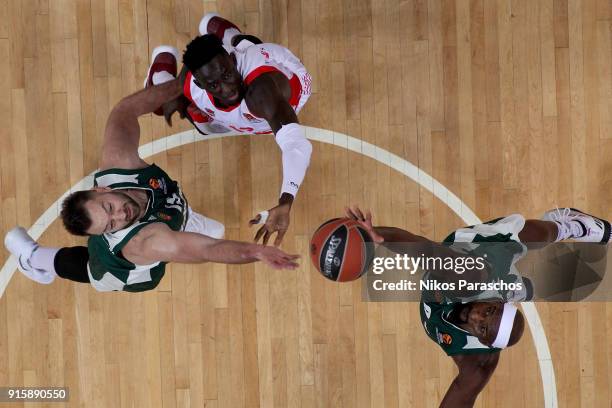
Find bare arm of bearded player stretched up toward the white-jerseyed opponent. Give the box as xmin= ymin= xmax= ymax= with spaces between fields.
xmin=100 ymin=80 xmax=181 ymax=170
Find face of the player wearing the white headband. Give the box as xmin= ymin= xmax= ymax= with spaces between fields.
xmin=461 ymin=302 xmax=504 ymax=346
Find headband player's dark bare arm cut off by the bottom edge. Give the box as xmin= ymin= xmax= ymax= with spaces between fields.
xmin=440 ymin=352 xmax=499 ymax=408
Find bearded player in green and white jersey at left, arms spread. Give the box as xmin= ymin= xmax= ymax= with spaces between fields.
xmin=5 ymin=80 xmax=297 ymax=292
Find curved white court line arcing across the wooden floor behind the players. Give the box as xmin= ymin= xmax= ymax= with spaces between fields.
xmin=0 ymin=126 xmax=558 ymax=408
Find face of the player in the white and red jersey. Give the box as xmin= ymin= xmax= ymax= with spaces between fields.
xmin=193 ymin=54 xmax=244 ymax=106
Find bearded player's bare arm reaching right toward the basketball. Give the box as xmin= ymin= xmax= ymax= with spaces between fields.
xmin=123 ymin=223 xmax=298 ymax=269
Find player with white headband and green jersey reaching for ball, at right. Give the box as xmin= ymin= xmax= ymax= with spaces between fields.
xmin=346 ymin=207 xmax=610 ymax=408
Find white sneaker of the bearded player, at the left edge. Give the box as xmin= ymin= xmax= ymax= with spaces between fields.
xmin=4 ymin=227 xmax=55 ymax=285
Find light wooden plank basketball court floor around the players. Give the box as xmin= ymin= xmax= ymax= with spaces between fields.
xmin=0 ymin=0 xmax=612 ymax=408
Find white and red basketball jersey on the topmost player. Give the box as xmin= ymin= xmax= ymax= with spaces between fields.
xmin=183 ymin=40 xmax=312 ymax=134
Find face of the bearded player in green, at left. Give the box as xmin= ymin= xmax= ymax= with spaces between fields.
xmin=85 ymin=191 xmax=141 ymax=235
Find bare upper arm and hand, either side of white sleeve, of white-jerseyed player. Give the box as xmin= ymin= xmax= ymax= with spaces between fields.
xmin=245 ymin=72 xmax=299 ymax=246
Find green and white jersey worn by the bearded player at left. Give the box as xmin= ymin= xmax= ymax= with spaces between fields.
xmin=87 ymin=164 xmax=188 ymax=292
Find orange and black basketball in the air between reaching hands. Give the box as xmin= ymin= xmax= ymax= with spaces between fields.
xmin=310 ymin=218 xmax=374 ymax=282
